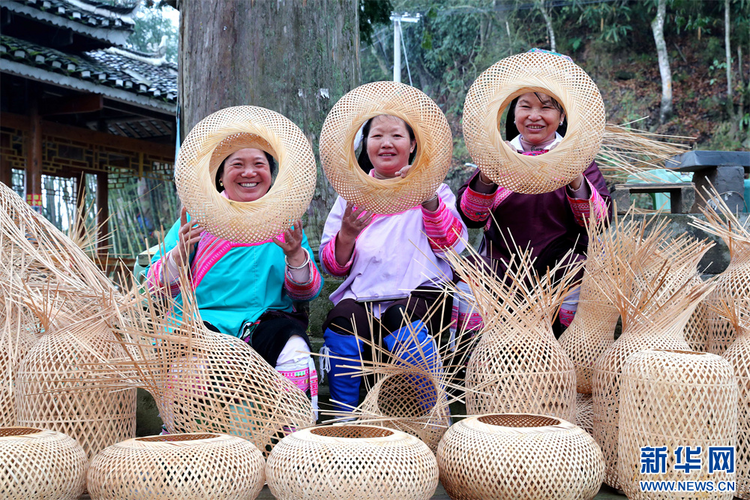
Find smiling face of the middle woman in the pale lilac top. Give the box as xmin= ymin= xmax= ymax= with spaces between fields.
xmin=367 ymin=115 xmax=417 ymax=178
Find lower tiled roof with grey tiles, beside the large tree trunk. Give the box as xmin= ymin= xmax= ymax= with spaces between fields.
xmin=0 ymin=35 xmax=177 ymax=108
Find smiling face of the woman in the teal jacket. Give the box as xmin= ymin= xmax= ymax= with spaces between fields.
xmin=221 ymin=148 xmax=271 ymax=201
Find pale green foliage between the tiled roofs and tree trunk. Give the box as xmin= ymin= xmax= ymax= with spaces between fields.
xmin=128 ymin=5 xmax=178 ymax=64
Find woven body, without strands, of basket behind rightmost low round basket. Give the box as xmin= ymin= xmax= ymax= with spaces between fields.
xmin=466 ymin=320 xmax=576 ymax=421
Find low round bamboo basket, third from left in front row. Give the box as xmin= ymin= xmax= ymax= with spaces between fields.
xmin=266 ymin=425 xmax=438 ymax=500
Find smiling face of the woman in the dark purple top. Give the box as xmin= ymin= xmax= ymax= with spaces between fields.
xmin=515 ymin=92 xmax=565 ymax=145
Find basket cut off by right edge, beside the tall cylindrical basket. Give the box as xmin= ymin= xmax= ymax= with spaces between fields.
xmin=714 ymin=298 xmax=750 ymax=500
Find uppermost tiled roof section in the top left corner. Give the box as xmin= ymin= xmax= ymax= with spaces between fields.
xmin=0 ymin=0 xmax=138 ymax=44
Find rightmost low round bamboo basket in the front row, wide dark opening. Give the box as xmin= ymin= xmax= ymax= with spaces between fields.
xmin=437 ymin=414 xmax=604 ymax=500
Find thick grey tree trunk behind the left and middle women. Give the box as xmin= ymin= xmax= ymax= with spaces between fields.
xmin=178 ymin=0 xmax=360 ymax=248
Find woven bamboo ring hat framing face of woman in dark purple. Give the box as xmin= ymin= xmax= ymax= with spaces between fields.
xmin=463 ymin=49 xmax=605 ymax=194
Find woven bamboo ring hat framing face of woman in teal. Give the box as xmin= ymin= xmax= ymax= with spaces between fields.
xmin=175 ymin=106 xmax=317 ymax=243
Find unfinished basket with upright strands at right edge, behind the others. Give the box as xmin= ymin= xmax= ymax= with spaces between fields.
xmin=690 ymin=187 xmax=750 ymax=354
